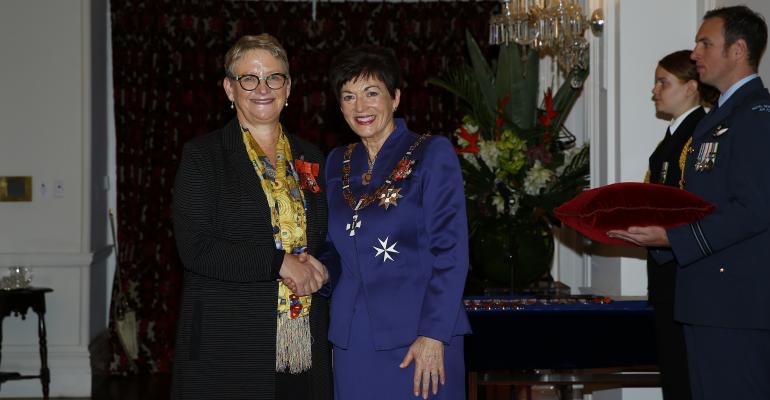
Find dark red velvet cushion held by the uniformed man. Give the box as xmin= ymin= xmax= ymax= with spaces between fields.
xmin=554 ymin=182 xmax=716 ymax=244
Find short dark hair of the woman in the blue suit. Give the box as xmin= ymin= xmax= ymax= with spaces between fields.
xmin=329 ymin=45 xmax=402 ymax=101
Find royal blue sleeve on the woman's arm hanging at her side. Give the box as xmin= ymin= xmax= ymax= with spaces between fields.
xmin=417 ymin=137 xmax=468 ymax=343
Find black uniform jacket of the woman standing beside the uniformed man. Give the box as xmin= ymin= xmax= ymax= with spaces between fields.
xmin=647 ymin=107 xmax=706 ymax=303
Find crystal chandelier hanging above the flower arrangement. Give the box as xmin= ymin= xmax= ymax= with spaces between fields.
xmin=489 ymin=0 xmax=588 ymax=71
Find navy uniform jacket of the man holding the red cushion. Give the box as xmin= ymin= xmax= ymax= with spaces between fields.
xmin=655 ymin=78 xmax=770 ymax=329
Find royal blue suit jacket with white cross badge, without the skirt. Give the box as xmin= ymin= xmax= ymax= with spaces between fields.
xmin=326 ymin=119 xmax=470 ymax=350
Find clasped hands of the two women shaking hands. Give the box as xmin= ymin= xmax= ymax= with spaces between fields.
xmin=278 ymin=253 xmax=329 ymax=296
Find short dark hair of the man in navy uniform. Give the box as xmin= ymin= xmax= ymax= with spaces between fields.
xmin=703 ymin=6 xmax=767 ymax=69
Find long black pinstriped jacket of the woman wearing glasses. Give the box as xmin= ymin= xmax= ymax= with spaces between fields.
xmin=172 ymin=119 xmax=331 ymax=400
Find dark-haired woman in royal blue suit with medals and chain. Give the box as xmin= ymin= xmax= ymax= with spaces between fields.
xmin=326 ymin=46 xmax=470 ymax=400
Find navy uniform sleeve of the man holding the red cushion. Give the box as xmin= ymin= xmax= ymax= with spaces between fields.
xmin=668 ymin=107 xmax=770 ymax=266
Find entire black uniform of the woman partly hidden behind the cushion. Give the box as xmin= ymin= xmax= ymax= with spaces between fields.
xmin=645 ymin=107 xmax=706 ymax=400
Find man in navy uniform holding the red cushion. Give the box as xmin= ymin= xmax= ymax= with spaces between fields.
xmin=608 ymin=6 xmax=770 ymax=400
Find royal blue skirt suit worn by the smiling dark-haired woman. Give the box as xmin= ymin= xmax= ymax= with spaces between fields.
xmin=326 ymin=119 xmax=470 ymax=400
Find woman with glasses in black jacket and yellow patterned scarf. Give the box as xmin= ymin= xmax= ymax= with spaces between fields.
xmin=172 ymin=34 xmax=332 ymax=400
